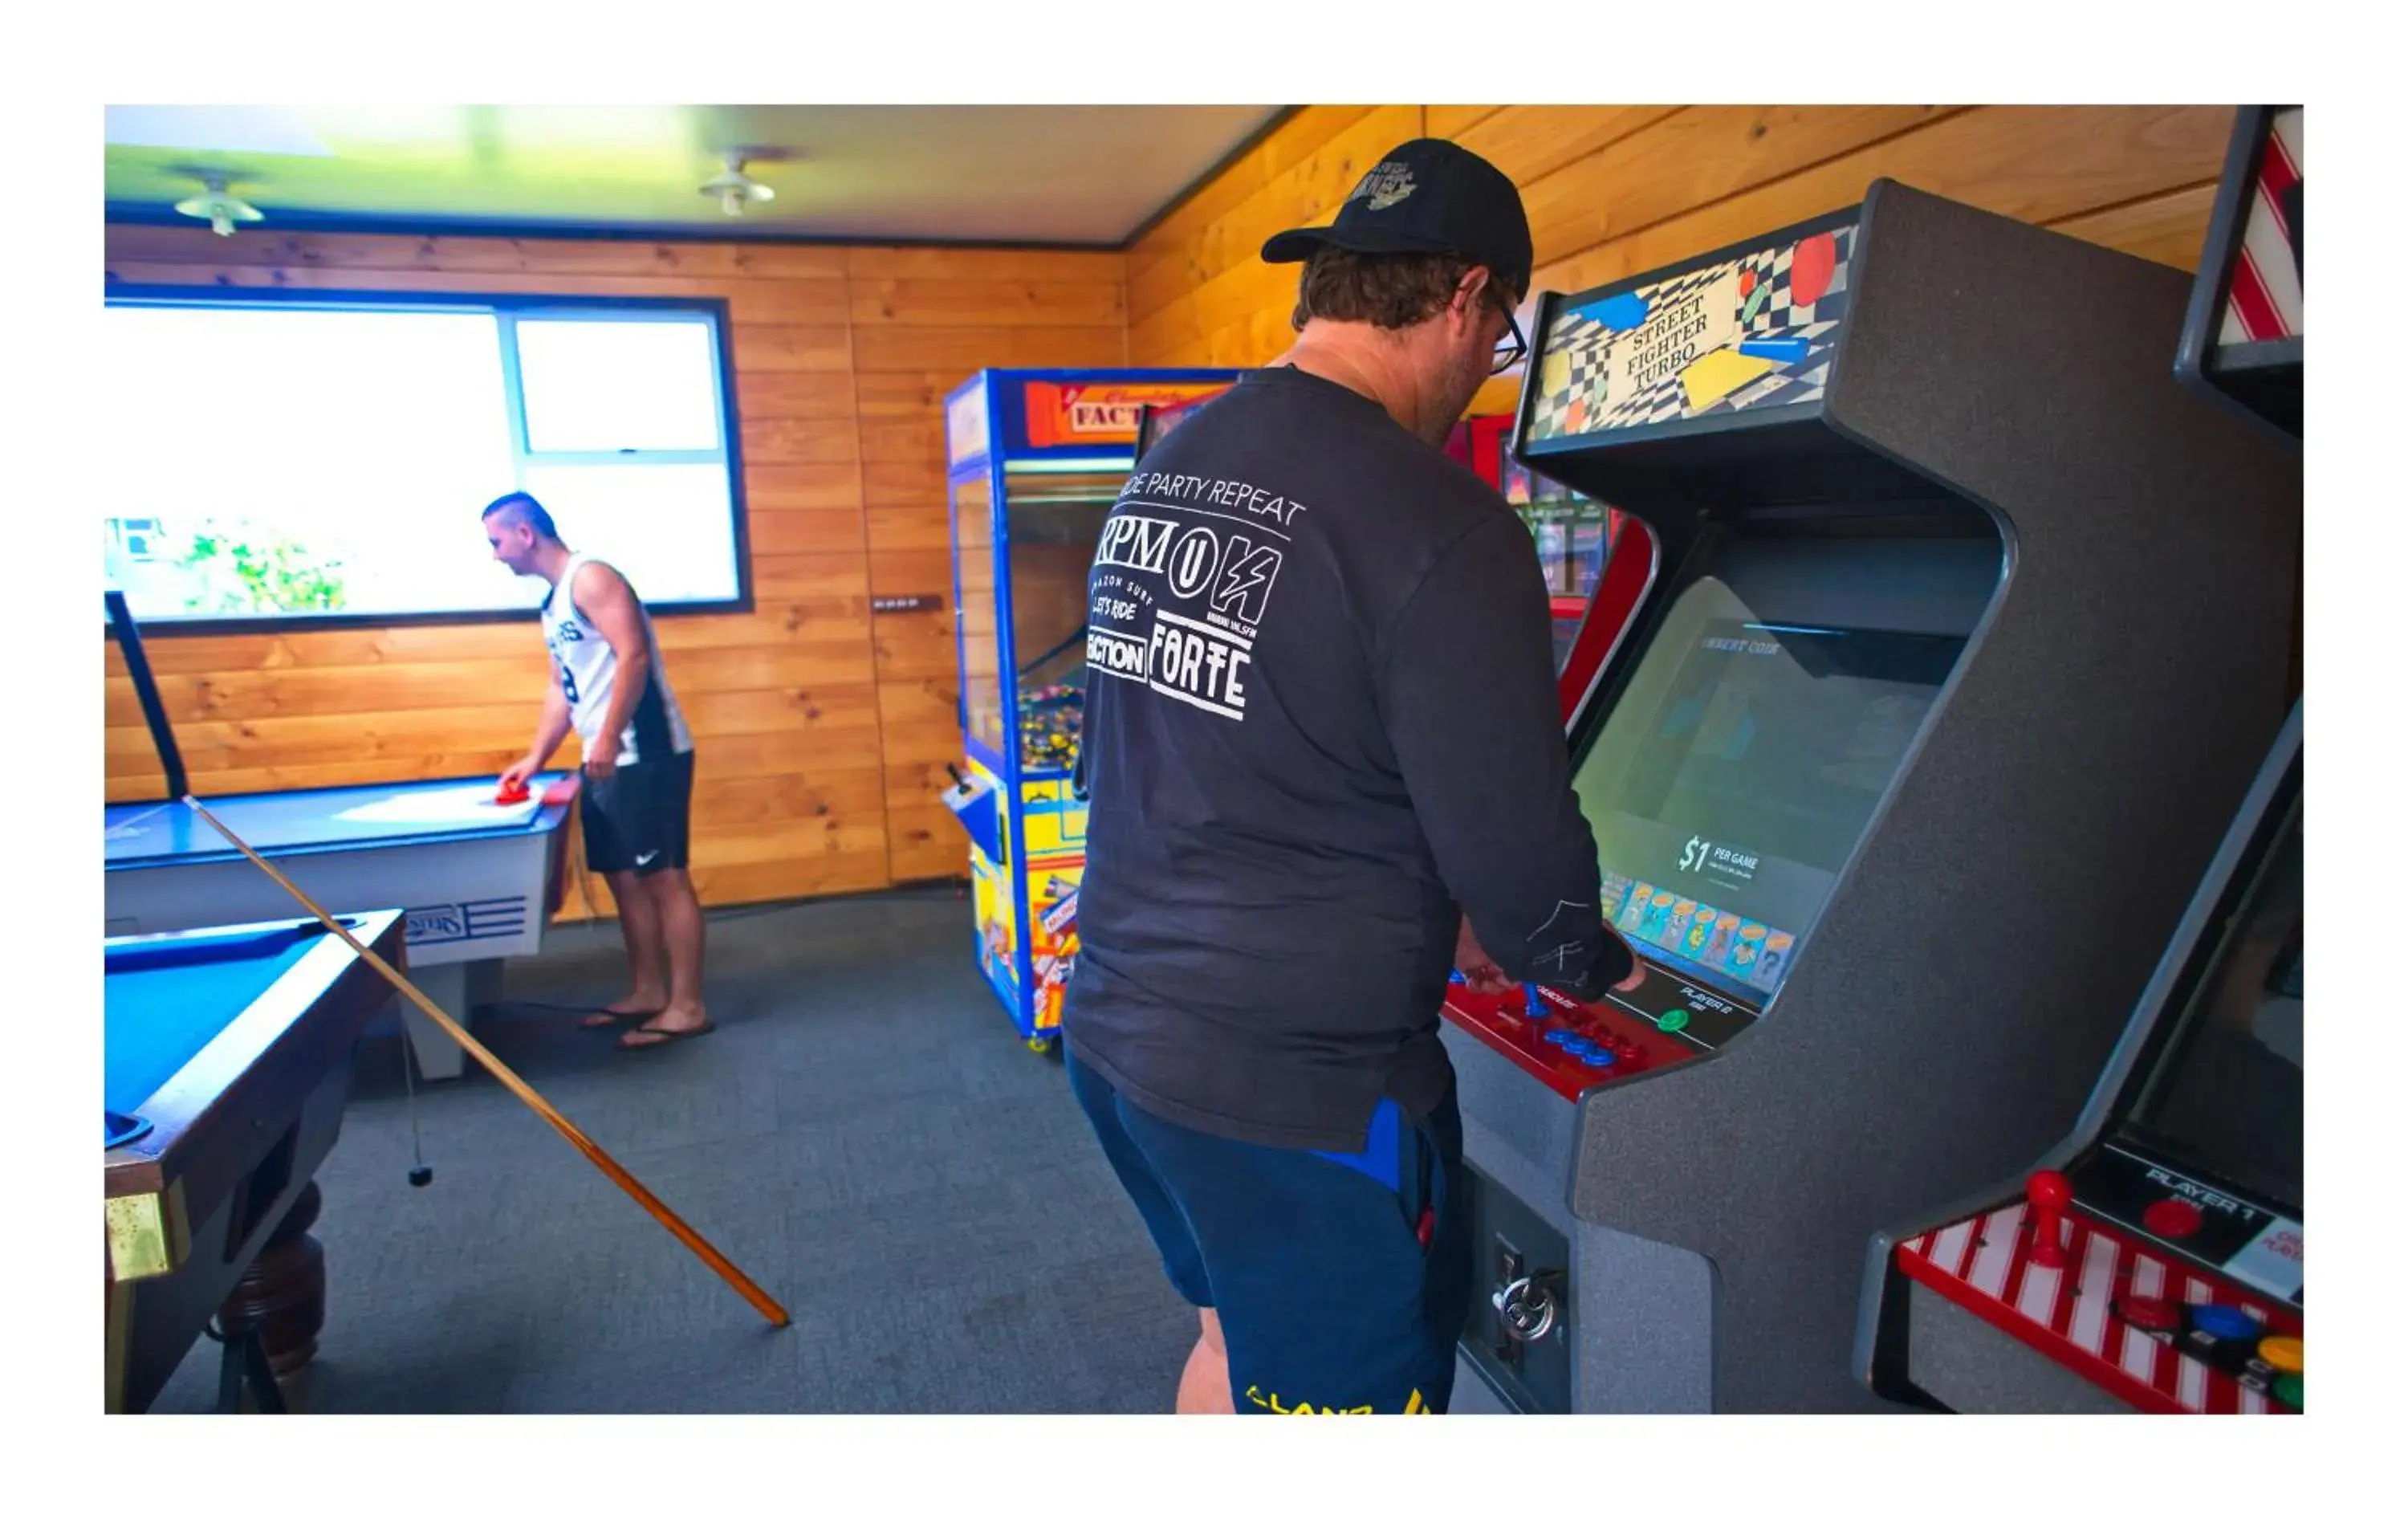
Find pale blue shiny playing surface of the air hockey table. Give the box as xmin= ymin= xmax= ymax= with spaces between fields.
xmin=104 ymin=775 xmax=568 ymax=869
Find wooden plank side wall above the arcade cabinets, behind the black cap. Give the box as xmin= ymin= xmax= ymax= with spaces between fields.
xmin=1127 ymin=106 xmax=2232 ymax=380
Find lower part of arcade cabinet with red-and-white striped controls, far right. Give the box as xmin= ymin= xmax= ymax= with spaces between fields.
xmin=1857 ymin=708 xmax=2307 ymax=1413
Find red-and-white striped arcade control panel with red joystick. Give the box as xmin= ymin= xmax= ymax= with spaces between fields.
xmin=1893 ymin=1160 xmax=2307 ymax=1413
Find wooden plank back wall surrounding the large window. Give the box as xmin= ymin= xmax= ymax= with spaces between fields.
xmin=106 ymin=226 xmax=1127 ymax=914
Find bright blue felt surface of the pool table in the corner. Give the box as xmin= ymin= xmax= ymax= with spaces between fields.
xmin=101 ymin=922 xmax=349 ymax=1114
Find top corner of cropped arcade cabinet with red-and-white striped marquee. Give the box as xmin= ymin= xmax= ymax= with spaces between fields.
xmin=2174 ymin=106 xmax=2307 ymax=441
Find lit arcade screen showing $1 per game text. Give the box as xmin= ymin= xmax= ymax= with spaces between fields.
xmin=1572 ymin=578 xmax=1965 ymax=1006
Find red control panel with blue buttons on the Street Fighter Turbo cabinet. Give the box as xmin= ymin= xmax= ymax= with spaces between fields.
xmin=1445 ymin=955 xmax=1758 ymax=1102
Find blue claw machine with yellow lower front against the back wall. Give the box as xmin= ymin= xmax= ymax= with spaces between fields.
xmin=944 ymin=369 xmax=1238 ymax=1052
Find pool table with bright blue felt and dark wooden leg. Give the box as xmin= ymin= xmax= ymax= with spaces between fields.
xmin=104 ymin=910 xmax=407 ymax=1413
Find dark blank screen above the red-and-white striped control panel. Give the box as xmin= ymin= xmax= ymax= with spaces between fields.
xmin=2131 ymin=799 xmax=2307 ymax=1216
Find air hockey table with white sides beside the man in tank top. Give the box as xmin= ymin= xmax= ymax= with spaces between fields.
xmin=104 ymin=772 xmax=578 ymax=1081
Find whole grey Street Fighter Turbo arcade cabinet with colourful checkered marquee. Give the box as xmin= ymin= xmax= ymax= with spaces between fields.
xmin=1445 ymin=181 xmax=2300 ymax=1413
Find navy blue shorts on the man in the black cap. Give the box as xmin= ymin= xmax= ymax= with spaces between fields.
xmin=1067 ymin=1054 xmax=1471 ymax=1413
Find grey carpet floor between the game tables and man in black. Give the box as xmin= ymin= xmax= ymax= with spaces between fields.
xmin=143 ymin=888 xmax=1194 ymax=1413
